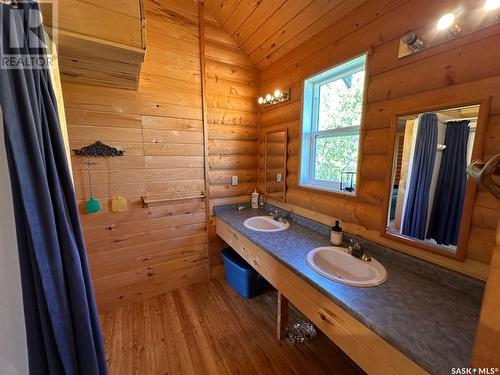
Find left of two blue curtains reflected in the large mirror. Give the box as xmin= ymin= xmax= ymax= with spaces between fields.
xmin=401 ymin=113 xmax=438 ymax=240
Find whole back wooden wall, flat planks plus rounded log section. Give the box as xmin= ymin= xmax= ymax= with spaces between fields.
xmin=63 ymin=0 xmax=258 ymax=310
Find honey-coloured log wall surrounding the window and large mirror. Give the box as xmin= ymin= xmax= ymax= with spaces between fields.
xmin=260 ymin=0 xmax=500 ymax=277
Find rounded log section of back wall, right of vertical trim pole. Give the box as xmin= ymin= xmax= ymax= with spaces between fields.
xmin=204 ymin=10 xmax=260 ymax=277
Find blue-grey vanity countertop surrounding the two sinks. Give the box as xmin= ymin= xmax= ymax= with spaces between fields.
xmin=215 ymin=205 xmax=484 ymax=374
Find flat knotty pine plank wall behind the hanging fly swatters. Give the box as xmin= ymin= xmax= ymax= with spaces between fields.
xmin=63 ymin=0 xmax=204 ymax=310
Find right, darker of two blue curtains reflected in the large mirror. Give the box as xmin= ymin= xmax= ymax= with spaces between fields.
xmin=427 ymin=120 xmax=470 ymax=246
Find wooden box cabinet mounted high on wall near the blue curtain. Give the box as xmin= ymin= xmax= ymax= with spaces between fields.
xmin=42 ymin=0 xmax=146 ymax=90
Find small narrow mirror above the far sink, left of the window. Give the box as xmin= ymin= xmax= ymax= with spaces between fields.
xmin=265 ymin=130 xmax=288 ymax=202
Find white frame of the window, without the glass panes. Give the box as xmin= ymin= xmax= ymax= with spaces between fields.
xmin=299 ymin=53 xmax=368 ymax=196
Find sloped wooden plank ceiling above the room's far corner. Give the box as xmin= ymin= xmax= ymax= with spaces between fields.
xmin=204 ymin=0 xmax=367 ymax=69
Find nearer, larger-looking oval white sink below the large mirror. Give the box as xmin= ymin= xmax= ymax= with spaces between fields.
xmin=306 ymin=246 xmax=387 ymax=287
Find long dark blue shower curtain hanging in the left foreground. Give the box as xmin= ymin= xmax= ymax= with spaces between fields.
xmin=0 ymin=1 xmax=107 ymax=375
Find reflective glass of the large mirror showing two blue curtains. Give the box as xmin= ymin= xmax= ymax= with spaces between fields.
xmin=387 ymin=105 xmax=479 ymax=254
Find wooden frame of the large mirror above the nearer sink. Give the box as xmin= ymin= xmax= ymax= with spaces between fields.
xmin=380 ymin=97 xmax=491 ymax=262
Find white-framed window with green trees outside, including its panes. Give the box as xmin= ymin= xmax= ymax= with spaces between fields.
xmin=300 ymin=55 xmax=366 ymax=194
